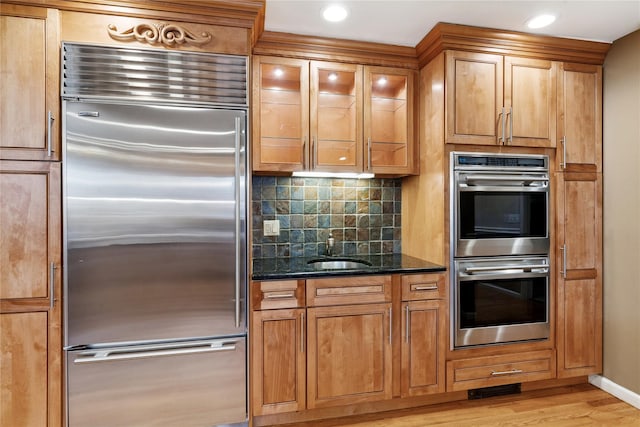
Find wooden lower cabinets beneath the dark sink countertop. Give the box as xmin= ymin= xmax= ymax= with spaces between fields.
xmin=251 ymin=273 xmax=448 ymax=416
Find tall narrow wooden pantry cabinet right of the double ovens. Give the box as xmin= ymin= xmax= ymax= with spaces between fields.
xmin=556 ymin=63 xmax=602 ymax=378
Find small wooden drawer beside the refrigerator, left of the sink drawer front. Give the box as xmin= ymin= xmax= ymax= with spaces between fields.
xmin=251 ymin=280 xmax=304 ymax=310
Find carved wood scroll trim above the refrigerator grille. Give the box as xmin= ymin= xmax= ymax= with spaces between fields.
xmin=107 ymin=23 xmax=213 ymax=46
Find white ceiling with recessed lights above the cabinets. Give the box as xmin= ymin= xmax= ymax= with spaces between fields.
xmin=265 ymin=0 xmax=640 ymax=47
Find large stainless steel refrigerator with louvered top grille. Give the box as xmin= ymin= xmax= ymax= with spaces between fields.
xmin=63 ymin=43 xmax=247 ymax=427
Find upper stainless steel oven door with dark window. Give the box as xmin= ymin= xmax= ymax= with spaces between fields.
xmin=453 ymin=170 xmax=549 ymax=257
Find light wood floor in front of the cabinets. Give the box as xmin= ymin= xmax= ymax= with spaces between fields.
xmin=287 ymin=384 xmax=640 ymax=427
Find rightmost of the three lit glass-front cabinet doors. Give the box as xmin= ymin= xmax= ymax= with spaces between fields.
xmin=364 ymin=67 xmax=416 ymax=174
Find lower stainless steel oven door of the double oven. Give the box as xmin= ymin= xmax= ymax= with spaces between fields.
xmin=453 ymin=256 xmax=549 ymax=348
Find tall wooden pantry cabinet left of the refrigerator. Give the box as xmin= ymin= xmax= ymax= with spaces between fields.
xmin=0 ymin=3 xmax=62 ymax=427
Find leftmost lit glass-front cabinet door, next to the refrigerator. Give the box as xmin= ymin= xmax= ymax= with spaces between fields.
xmin=252 ymin=56 xmax=309 ymax=172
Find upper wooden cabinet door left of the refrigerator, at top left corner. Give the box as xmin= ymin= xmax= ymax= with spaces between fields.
xmin=0 ymin=4 xmax=60 ymax=160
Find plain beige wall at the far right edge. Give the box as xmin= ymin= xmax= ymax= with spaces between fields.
xmin=603 ymin=31 xmax=640 ymax=394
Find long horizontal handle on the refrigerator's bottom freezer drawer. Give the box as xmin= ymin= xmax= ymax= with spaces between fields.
xmin=73 ymin=342 xmax=236 ymax=363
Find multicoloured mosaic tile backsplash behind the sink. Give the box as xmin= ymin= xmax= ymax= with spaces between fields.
xmin=251 ymin=176 xmax=402 ymax=258
